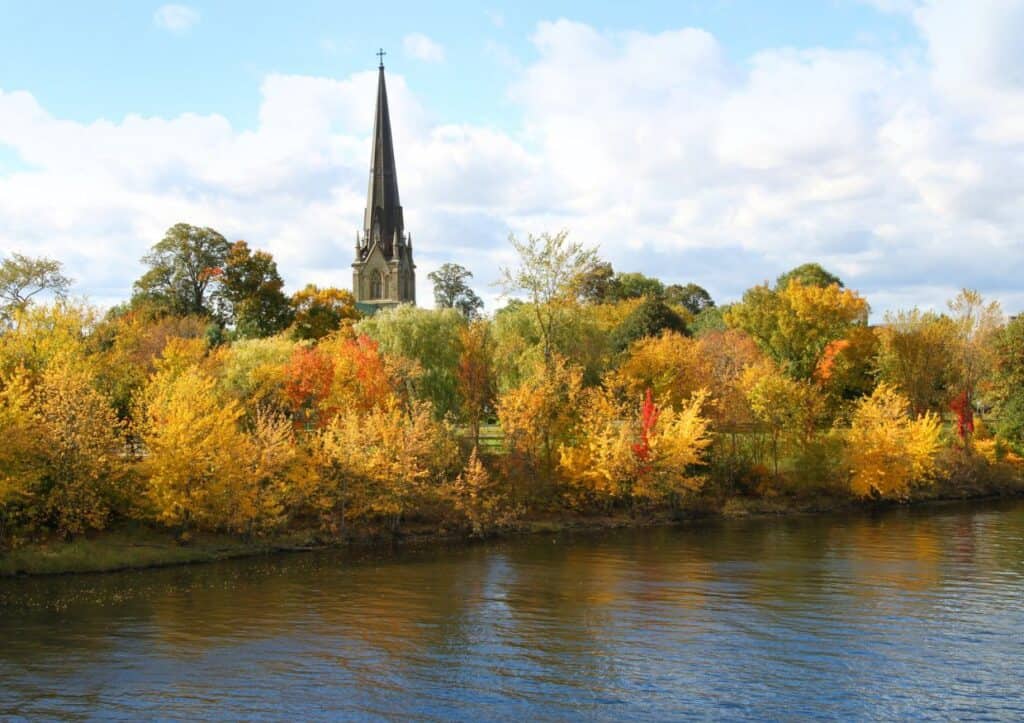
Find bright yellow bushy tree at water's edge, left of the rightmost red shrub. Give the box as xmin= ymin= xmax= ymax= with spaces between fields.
xmin=847 ymin=383 xmax=941 ymax=499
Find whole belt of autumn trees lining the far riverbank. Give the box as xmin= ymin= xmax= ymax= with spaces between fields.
xmin=0 ymin=224 xmax=1024 ymax=545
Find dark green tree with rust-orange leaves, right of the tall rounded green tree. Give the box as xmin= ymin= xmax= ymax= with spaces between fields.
xmin=218 ymin=241 xmax=294 ymax=337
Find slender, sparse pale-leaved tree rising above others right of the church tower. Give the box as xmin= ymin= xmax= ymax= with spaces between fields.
xmin=499 ymin=230 xmax=598 ymax=366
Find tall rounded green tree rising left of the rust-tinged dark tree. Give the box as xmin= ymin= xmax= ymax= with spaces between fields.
xmin=133 ymin=223 xmax=230 ymax=316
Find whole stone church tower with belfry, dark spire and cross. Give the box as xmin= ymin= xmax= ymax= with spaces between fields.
xmin=352 ymin=50 xmax=416 ymax=311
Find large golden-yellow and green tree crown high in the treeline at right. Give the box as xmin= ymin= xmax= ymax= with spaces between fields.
xmin=725 ymin=279 xmax=868 ymax=379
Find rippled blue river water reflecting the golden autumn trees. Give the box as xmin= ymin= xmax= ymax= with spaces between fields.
xmin=0 ymin=502 xmax=1024 ymax=720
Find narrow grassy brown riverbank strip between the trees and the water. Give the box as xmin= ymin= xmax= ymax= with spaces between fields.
xmin=0 ymin=484 xmax=1024 ymax=580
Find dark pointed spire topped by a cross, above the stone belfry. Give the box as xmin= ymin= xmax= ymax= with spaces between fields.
xmin=364 ymin=50 xmax=406 ymax=257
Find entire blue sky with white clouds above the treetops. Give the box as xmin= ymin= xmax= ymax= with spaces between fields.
xmin=0 ymin=0 xmax=1024 ymax=314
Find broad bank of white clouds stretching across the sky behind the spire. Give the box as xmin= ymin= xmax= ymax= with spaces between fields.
xmin=0 ymin=1 xmax=1024 ymax=312
